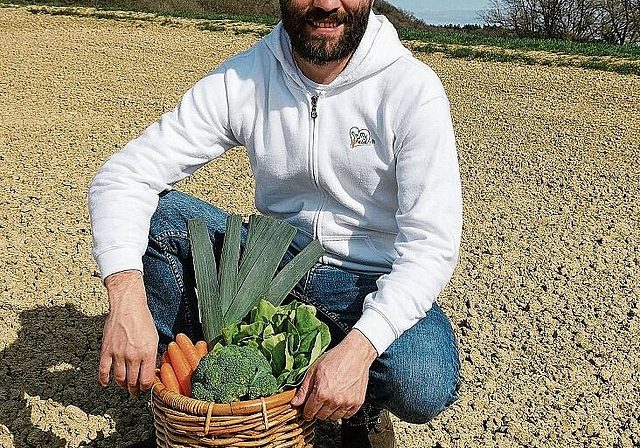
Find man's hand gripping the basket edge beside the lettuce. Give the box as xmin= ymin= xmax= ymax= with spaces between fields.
xmin=291 ymin=330 xmax=378 ymax=420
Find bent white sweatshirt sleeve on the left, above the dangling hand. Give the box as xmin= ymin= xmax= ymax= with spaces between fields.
xmin=88 ymin=69 xmax=238 ymax=280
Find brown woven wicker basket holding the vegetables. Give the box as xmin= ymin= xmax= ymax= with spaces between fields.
xmin=151 ymin=377 xmax=314 ymax=448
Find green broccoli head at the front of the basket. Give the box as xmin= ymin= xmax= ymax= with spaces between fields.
xmin=191 ymin=345 xmax=278 ymax=403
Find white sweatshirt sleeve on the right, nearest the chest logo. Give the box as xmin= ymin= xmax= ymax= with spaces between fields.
xmin=354 ymin=91 xmax=462 ymax=354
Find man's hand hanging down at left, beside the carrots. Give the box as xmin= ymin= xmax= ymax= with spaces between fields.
xmin=99 ymin=271 xmax=158 ymax=395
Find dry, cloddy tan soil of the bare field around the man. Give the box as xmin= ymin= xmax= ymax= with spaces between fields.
xmin=0 ymin=6 xmax=640 ymax=448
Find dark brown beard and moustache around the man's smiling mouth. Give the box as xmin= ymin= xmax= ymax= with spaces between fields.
xmin=280 ymin=0 xmax=371 ymax=65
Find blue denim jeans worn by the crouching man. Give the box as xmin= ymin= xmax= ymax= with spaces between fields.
xmin=143 ymin=191 xmax=460 ymax=423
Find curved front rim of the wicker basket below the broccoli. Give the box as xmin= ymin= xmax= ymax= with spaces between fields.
xmin=151 ymin=375 xmax=297 ymax=416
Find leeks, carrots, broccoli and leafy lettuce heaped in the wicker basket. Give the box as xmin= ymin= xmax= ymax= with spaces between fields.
xmin=165 ymin=215 xmax=330 ymax=402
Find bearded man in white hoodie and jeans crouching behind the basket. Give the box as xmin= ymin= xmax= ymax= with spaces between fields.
xmin=89 ymin=0 xmax=462 ymax=447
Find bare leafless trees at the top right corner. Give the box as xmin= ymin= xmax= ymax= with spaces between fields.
xmin=481 ymin=0 xmax=640 ymax=44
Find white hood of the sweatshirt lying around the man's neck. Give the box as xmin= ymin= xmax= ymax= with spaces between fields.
xmin=264 ymin=12 xmax=411 ymax=89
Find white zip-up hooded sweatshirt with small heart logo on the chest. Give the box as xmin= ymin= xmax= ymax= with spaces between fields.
xmin=89 ymin=14 xmax=462 ymax=353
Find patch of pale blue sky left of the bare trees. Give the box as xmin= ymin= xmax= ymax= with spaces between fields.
xmin=387 ymin=0 xmax=489 ymax=25
